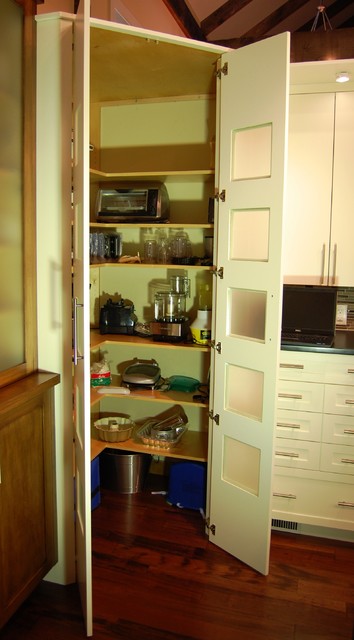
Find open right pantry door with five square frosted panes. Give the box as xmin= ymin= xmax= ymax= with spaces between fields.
xmin=209 ymin=34 xmax=289 ymax=574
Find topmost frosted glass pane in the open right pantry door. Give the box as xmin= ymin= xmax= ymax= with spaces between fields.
xmin=231 ymin=124 xmax=272 ymax=180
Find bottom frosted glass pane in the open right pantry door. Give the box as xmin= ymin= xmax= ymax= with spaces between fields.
xmin=222 ymin=436 xmax=261 ymax=496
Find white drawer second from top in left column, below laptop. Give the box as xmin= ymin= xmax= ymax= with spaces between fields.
xmin=277 ymin=380 xmax=324 ymax=412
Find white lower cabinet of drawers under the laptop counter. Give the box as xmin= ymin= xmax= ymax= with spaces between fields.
xmin=273 ymin=351 xmax=354 ymax=539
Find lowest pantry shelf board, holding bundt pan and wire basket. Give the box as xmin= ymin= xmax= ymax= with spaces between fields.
xmin=91 ymin=430 xmax=208 ymax=462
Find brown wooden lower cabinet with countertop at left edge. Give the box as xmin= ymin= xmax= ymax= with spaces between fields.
xmin=0 ymin=372 xmax=59 ymax=627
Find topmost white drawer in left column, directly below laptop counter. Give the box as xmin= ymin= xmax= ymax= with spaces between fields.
xmin=279 ymin=351 xmax=324 ymax=382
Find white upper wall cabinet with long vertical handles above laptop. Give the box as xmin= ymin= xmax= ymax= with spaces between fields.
xmin=283 ymin=85 xmax=354 ymax=286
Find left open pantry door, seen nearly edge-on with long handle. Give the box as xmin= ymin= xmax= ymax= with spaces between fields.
xmin=73 ymin=0 xmax=92 ymax=635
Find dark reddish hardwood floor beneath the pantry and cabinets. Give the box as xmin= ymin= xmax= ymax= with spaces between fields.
xmin=0 ymin=472 xmax=354 ymax=640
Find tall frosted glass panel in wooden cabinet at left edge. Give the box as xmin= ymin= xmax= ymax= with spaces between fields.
xmin=0 ymin=0 xmax=25 ymax=371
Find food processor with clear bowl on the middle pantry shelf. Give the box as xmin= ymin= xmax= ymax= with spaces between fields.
xmin=150 ymin=276 xmax=189 ymax=342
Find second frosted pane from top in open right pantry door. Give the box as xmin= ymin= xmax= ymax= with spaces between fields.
xmin=229 ymin=209 xmax=269 ymax=262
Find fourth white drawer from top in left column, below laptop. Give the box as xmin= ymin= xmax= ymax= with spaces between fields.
xmin=274 ymin=438 xmax=321 ymax=471
